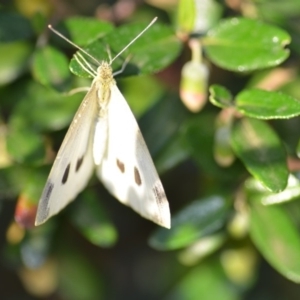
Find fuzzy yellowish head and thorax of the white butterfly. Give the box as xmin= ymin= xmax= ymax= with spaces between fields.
xmin=94 ymin=61 xmax=116 ymax=111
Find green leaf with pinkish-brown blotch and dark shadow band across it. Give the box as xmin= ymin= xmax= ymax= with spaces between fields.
xmin=231 ymin=118 xmax=289 ymax=192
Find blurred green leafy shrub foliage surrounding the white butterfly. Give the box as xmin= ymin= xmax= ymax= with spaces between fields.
xmin=0 ymin=0 xmax=300 ymax=300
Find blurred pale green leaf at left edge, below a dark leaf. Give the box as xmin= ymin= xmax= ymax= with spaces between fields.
xmin=0 ymin=41 xmax=32 ymax=86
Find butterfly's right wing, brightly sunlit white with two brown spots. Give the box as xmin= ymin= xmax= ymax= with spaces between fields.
xmin=94 ymin=84 xmax=170 ymax=228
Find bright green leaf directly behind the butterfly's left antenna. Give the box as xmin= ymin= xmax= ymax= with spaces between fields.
xmin=61 ymin=17 xmax=114 ymax=46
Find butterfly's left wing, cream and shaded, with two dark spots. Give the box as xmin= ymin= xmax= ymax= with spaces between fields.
xmin=35 ymin=85 xmax=97 ymax=225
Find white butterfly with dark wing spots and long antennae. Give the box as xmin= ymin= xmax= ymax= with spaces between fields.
xmin=35 ymin=19 xmax=170 ymax=228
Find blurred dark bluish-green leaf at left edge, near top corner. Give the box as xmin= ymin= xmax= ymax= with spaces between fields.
xmin=0 ymin=11 xmax=33 ymax=42
